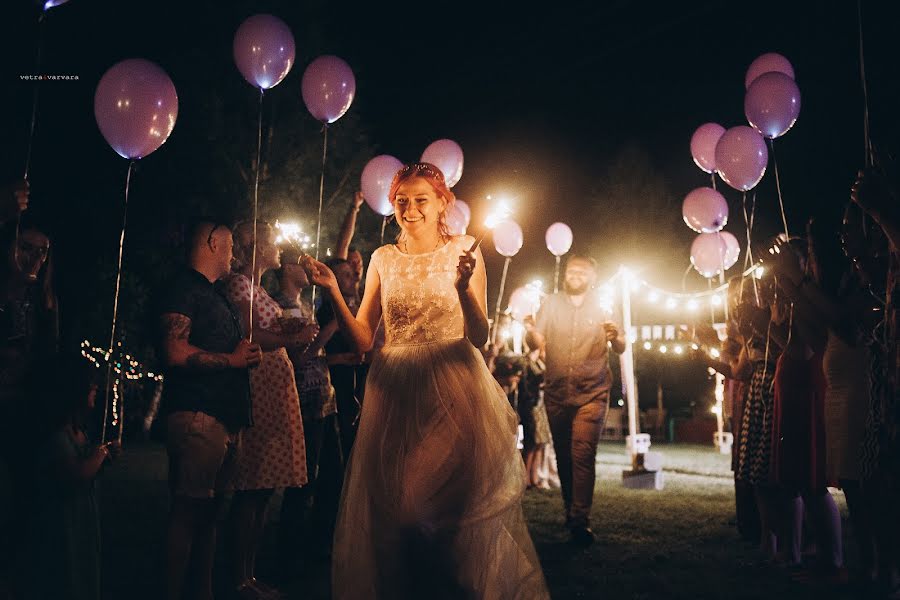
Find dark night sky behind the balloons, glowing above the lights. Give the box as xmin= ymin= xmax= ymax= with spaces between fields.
xmin=2 ymin=0 xmax=900 ymax=354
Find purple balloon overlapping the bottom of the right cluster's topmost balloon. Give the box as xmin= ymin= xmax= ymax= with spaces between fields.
xmin=744 ymin=71 xmax=800 ymax=139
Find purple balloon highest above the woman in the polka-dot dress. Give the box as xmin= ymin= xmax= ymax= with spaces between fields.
xmin=232 ymin=15 xmax=295 ymax=90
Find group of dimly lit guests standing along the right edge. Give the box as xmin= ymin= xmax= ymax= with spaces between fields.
xmin=710 ymin=169 xmax=900 ymax=597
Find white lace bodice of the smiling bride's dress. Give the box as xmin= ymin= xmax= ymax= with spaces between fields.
xmin=370 ymin=236 xmax=474 ymax=346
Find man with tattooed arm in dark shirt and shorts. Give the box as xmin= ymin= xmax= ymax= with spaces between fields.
xmin=158 ymin=219 xmax=261 ymax=600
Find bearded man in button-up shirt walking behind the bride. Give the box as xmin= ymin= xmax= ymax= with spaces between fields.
xmin=533 ymin=254 xmax=625 ymax=546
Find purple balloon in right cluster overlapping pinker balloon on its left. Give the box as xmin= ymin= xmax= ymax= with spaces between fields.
xmin=716 ymin=125 xmax=769 ymax=192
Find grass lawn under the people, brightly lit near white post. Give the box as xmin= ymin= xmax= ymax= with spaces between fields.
xmin=101 ymin=443 xmax=861 ymax=600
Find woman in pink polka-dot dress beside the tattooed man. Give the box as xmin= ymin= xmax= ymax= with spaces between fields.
xmin=226 ymin=222 xmax=318 ymax=597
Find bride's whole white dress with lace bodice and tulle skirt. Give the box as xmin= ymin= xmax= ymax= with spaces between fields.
xmin=332 ymin=236 xmax=549 ymax=600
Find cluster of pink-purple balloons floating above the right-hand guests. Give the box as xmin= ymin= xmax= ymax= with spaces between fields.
xmin=682 ymin=52 xmax=800 ymax=277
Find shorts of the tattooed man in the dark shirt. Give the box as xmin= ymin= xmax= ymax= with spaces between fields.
xmin=166 ymin=411 xmax=241 ymax=498
